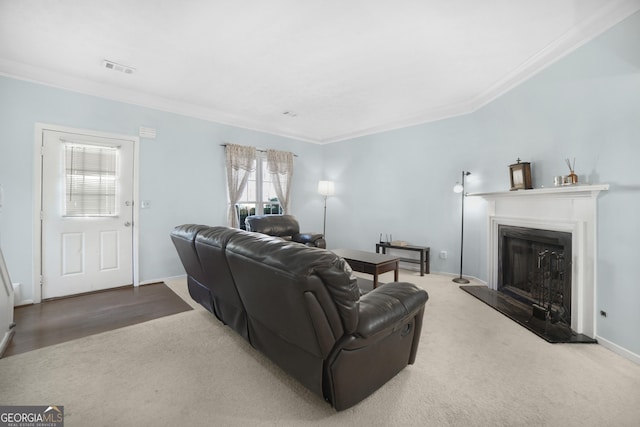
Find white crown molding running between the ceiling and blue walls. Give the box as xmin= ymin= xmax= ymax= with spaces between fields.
xmin=0 ymin=0 xmax=640 ymax=144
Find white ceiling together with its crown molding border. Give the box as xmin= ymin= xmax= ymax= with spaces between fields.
xmin=0 ymin=0 xmax=640 ymax=143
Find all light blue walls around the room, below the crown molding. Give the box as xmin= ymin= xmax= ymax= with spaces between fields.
xmin=0 ymin=10 xmax=640 ymax=355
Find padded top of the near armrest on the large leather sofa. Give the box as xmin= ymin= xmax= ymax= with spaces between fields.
xmin=355 ymin=282 xmax=429 ymax=338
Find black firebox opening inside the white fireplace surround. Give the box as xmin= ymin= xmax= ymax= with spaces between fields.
xmin=498 ymin=225 xmax=572 ymax=328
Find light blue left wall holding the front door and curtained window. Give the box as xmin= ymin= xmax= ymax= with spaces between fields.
xmin=0 ymin=77 xmax=322 ymax=299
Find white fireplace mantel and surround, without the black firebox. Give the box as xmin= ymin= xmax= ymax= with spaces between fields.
xmin=467 ymin=184 xmax=609 ymax=338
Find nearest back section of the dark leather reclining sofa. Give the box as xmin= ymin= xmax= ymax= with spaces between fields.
xmin=227 ymin=232 xmax=360 ymax=357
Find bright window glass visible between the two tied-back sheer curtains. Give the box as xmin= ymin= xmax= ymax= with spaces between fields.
xmin=238 ymin=153 xmax=282 ymax=225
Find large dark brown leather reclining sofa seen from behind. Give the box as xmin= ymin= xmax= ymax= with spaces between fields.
xmin=171 ymin=224 xmax=428 ymax=410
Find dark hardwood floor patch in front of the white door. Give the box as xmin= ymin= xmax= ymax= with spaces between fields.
xmin=3 ymin=283 xmax=192 ymax=357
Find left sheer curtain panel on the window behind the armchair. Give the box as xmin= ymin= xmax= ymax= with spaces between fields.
xmin=225 ymin=144 xmax=256 ymax=228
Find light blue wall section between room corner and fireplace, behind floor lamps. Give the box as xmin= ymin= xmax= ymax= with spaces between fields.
xmin=325 ymin=116 xmax=478 ymax=273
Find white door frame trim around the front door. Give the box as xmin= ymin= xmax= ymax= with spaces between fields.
xmin=32 ymin=123 xmax=140 ymax=304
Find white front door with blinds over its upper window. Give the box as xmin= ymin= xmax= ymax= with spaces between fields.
xmin=41 ymin=130 xmax=135 ymax=299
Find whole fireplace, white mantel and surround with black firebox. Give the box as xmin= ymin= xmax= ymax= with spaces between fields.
xmin=476 ymin=184 xmax=609 ymax=338
